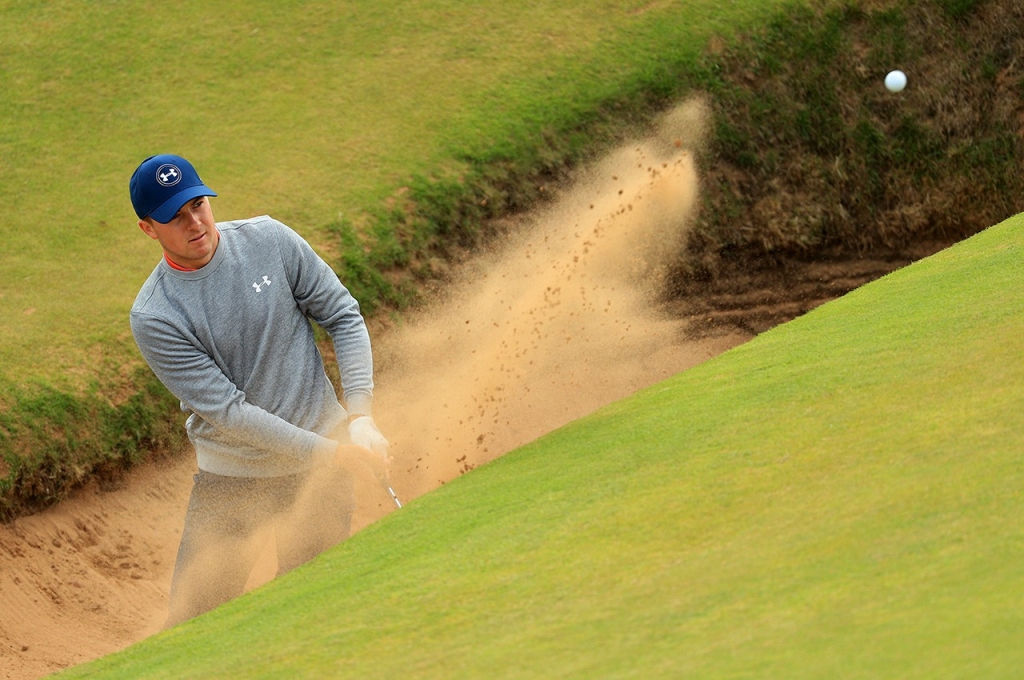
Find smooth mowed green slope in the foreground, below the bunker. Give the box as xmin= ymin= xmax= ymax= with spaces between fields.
xmin=66 ymin=215 xmax=1024 ymax=679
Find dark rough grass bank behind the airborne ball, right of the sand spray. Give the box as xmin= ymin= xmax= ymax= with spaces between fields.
xmin=674 ymin=0 xmax=1024 ymax=284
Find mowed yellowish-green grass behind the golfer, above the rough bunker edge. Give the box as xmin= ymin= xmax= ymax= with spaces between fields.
xmin=0 ymin=0 xmax=783 ymax=388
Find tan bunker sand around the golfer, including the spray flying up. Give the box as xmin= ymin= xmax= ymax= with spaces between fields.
xmin=0 ymin=98 xmax=749 ymax=678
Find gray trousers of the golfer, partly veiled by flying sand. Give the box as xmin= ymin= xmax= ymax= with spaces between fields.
xmin=165 ymin=466 xmax=354 ymax=628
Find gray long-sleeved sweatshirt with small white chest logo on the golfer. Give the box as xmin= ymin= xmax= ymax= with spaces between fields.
xmin=131 ymin=215 xmax=374 ymax=477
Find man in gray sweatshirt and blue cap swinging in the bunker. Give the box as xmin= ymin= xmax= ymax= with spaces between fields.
xmin=129 ymin=155 xmax=390 ymax=627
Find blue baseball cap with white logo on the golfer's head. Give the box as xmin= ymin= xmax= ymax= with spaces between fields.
xmin=128 ymin=154 xmax=217 ymax=224
